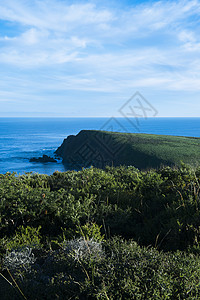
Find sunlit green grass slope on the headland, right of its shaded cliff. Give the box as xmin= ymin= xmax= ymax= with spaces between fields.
xmin=100 ymin=132 xmax=200 ymax=168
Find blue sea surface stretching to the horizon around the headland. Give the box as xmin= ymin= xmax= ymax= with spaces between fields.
xmin=0 ymin=117 xmax=200 ymax=174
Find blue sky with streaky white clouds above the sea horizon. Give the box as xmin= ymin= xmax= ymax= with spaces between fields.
xmin=0 ymin=0 xmax=200 ymax=117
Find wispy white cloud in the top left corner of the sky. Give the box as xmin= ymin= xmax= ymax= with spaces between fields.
xmin=0 ymin=0 xmax=112 ymax=32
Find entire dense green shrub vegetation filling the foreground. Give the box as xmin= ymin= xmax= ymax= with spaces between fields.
xmin=0 ymin=164 xmax=200 ymax=300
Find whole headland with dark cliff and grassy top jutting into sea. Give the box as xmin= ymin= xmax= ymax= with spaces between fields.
xmin=55 ymin=130 xmax=200 ymax=169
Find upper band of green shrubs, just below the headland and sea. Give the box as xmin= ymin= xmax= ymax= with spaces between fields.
xmin=0 ymin=164 xmax=200 ymax=250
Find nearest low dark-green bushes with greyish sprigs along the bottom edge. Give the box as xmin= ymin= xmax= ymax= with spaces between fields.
xmin=1 ymin=238 xmax=200 ymax=300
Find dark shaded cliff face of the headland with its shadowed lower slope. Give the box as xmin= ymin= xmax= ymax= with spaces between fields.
xmin=56 ymin=130 xmax=169 ymax=169
